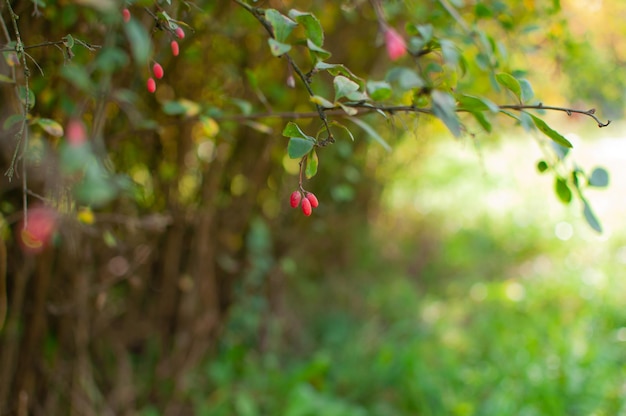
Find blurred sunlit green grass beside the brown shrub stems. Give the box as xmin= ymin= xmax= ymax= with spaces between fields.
xmin=176 ymin=126 xmax=626 ymax=416
